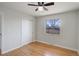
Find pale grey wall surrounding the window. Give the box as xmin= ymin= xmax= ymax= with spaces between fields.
xmin=37 ymin=11 xmax=77 ymax=50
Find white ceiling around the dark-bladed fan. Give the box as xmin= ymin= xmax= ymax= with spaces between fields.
xmin=0 ymin=2 xmax=79 ymax=16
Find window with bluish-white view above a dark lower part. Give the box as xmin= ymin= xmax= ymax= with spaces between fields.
xmin=46 ymin=18 xmax=61 ymax=34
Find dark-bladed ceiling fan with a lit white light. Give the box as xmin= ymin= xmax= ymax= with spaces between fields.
xmin=28 ymin=2 xmax=54 ymax=11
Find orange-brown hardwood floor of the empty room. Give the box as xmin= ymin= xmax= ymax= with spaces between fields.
xmin=2 ymin=42 xmax=77 ymax=56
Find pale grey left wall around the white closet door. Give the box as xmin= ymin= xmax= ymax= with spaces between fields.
xmin=0 ymin=7 xmax=34 ymax=53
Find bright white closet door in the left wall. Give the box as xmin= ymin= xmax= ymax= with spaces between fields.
xmin=22 ymin=19 xmax=32 ymax=45
